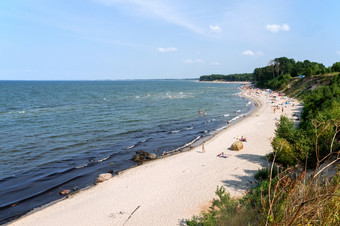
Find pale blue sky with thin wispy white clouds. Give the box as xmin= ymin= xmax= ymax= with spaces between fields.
xmin=0 ymin=0 xmax=340 ymax=80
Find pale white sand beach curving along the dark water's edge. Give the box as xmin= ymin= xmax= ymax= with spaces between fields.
xmin=12 ymin=87 xmax=298 ymax=225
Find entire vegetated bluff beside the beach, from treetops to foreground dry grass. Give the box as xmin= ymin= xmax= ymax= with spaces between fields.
xmin=187 ymin=57 xmax=340 ymax=225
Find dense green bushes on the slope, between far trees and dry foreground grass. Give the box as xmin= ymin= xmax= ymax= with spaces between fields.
xmin=272 ymin=75 xmax=340 ymax=167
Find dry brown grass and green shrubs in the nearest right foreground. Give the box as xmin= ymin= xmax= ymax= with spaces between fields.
xmin=186 ymin=168 xmax=340 ymax=226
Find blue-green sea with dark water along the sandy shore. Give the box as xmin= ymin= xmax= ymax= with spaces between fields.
xmin=0 ymin=80 xmax=254 ymax=224
